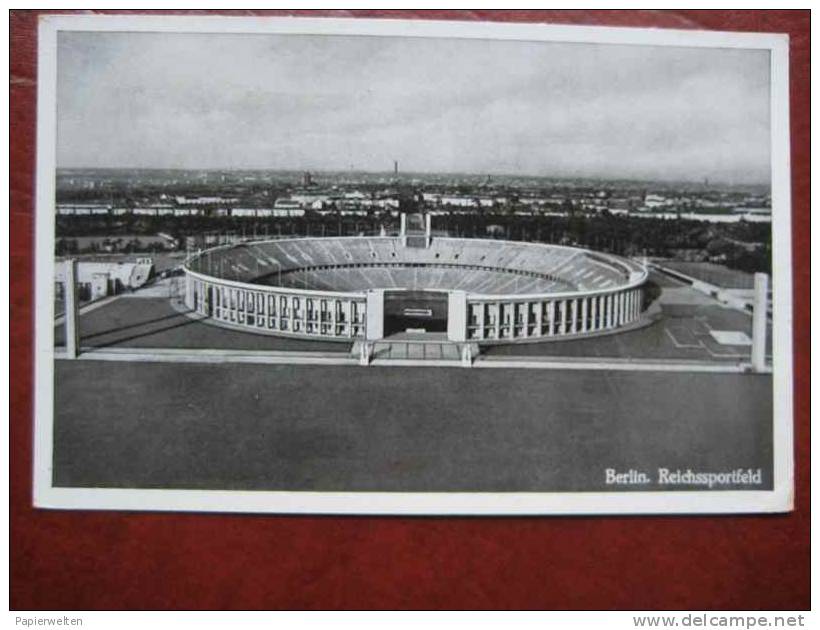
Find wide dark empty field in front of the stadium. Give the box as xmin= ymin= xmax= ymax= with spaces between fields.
xmin=54 ymin=360 xmax=772 ymax=491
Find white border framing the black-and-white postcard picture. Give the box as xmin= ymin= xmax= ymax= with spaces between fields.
xmin=33 ymin=15 xmax=794 ymax=515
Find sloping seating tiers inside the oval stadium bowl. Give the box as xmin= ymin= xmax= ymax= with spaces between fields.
xmin=188 ymin=237 xmax=639 ymax=295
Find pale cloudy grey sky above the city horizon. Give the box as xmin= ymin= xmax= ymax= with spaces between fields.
xmin=57 ymin=32 xmax=769 ymax=183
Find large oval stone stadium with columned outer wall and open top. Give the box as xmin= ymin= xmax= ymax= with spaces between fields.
xmin=184 ymin=215 xmax=647 ymax=344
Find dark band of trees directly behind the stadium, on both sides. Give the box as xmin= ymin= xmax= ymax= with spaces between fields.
xmin=57 ymin=212 xmax=771 ymax=272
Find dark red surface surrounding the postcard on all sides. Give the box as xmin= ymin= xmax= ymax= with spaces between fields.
xmin=10 ymin=11 xmax=810 ymax=609
